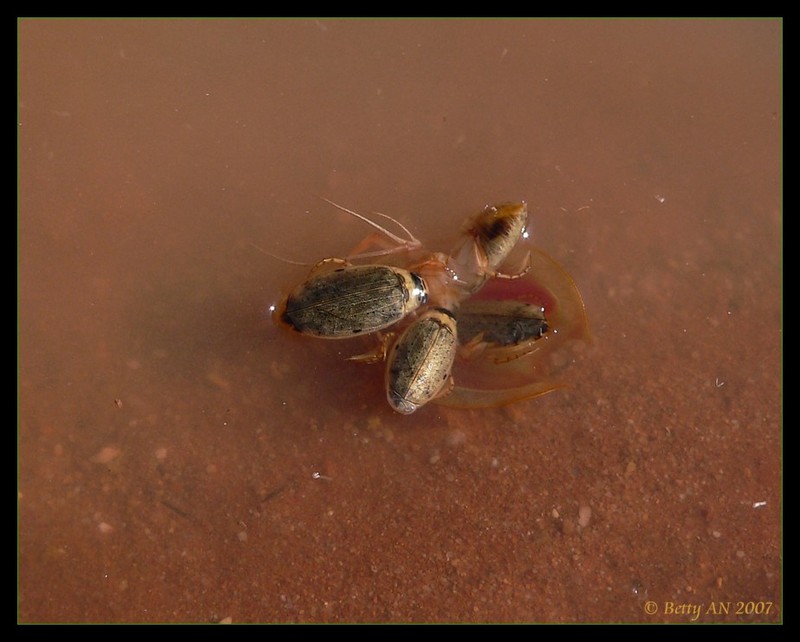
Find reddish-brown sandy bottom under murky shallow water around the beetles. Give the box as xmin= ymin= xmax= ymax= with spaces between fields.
xmin=18 ymin=20 xmax=782 ymax=623
